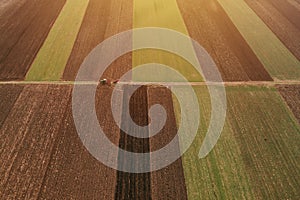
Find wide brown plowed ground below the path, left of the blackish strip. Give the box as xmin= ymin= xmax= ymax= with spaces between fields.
xmin=0 ymin=85 xmax=120 ymax=199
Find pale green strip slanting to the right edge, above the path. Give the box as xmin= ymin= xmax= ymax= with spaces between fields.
xmin=218 ymin=0 xmax=300 ymax=80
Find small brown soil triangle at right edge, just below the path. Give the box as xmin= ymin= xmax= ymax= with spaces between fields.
xmin=277 ymin=85 xmax=300 ymax=123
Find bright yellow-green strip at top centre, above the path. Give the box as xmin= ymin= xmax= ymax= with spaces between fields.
xmin=132 ymin=0 xmax=202 ymax=81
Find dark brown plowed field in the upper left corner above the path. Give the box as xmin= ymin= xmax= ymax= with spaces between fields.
xmin=0 ymin=0 xmax=65 ymax=80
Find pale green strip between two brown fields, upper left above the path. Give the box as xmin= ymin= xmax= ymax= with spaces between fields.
xmin=25 ymin=0 xmax=89 ymax=81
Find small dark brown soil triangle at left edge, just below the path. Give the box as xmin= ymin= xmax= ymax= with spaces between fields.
xmin=0 ymin=85 xmax=23 ymax=127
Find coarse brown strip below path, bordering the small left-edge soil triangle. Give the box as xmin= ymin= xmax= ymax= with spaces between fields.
xmin=0 ymin=85 xmax=71 ymax=199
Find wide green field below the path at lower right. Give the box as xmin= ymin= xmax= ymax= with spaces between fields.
xmin=174 ymin=86 xmax=300 ymax=199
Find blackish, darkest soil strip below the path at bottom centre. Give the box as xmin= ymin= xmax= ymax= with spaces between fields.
xmin=115 ymin=86 xmax=151 ymax=200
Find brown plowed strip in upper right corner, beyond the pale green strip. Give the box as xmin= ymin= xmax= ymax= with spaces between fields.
xmin=246 ymin=0 xmax=300 ymax=60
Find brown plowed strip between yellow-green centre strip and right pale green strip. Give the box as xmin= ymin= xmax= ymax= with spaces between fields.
xmin=177 ymin=0 xmax=272 ymax=81
